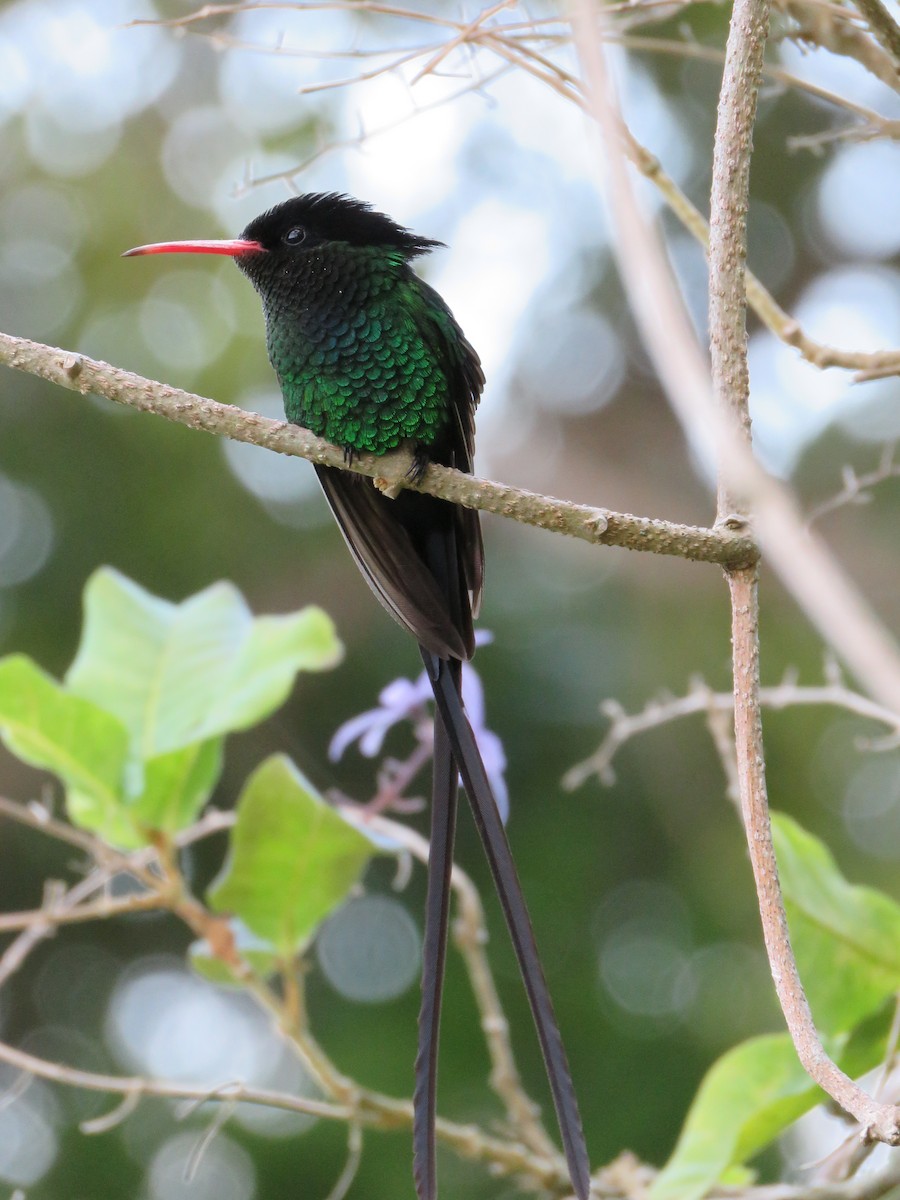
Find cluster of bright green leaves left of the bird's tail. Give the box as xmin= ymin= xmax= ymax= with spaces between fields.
xmin=0 ymin=568 xmax=391 ymax=978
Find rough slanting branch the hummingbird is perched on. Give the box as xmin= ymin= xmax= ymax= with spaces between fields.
xmin=0 ymin=334 xmax=757 ymax=565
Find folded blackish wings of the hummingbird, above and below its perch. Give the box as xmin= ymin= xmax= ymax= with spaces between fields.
xmin=316 ymin=274 xmax=484 ymax=659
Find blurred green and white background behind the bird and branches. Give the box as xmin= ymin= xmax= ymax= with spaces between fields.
xmin=0 ymin=0 xmax=900 ymax=1200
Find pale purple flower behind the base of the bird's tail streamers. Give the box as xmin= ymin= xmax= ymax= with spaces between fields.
xmin=328 ymin=631 xmax=509 ymax=822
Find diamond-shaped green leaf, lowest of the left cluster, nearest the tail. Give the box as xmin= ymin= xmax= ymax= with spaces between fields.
xmin=209 ymin=755 xmax=378 ymax=960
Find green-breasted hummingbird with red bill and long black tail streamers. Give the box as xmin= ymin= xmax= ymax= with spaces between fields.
xmin=124 ymin=193 xmax=590 ymax=1200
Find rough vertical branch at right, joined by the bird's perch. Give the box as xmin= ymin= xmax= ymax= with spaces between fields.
xmin=709 ymin=0 xmax=900 ymax=1144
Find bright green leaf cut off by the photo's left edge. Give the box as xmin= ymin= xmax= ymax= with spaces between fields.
xmin=0 ymin=654 xmax=128 ymax=812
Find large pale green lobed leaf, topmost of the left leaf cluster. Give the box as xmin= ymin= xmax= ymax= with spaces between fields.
xmin=66 ymin=566 xmax=343 ymax=758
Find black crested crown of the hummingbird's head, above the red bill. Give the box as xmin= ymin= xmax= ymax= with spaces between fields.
xmin=241 ymin=192 xmax=443 ymax=259
